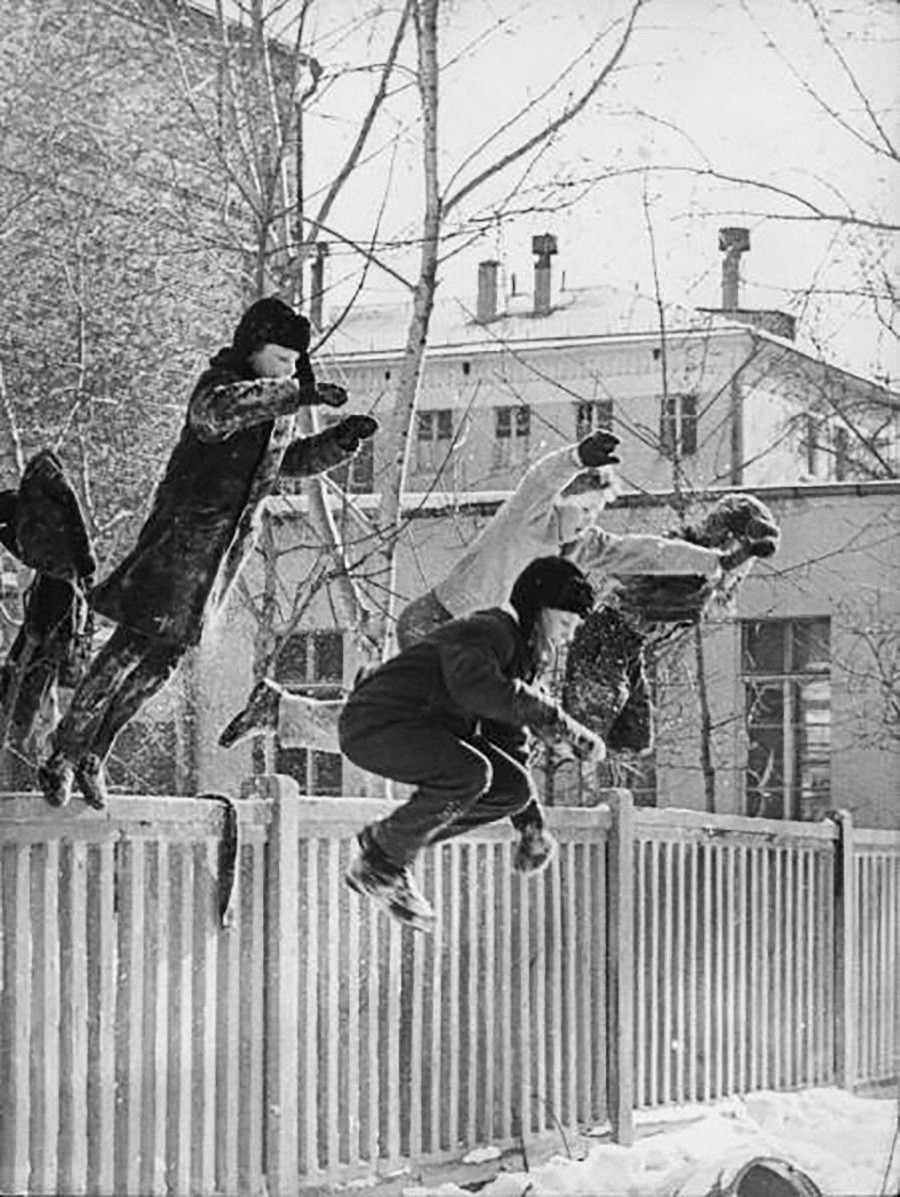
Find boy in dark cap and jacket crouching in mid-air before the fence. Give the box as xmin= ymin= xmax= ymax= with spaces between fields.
xmin=339 ymin=557 xmax=603 ymax=931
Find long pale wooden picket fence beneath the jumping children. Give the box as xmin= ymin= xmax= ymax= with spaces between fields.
xmin=0 ymin=778 xmax=900 ymax=1197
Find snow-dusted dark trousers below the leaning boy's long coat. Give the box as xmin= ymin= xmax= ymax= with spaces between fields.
xmin=53 ymin=627 xmax=184 ymax=761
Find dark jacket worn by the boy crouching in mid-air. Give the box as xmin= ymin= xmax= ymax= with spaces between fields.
xmin=340 ymin=607 xmax=586 ymax=760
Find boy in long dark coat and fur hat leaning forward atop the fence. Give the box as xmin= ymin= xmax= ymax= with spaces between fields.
xmin=39 ymin=298 xmax=378 ymax=808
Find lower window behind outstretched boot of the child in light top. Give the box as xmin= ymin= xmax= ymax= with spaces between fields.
xmin=274 ymin=632 xmax=343 ymax=797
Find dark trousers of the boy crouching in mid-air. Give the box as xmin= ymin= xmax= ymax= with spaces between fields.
xmin=339 ymin=704 xmax=543 ymax=868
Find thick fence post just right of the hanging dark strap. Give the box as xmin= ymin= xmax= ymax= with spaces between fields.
xmin=254 ymin=776 xmax=300 ymax=1197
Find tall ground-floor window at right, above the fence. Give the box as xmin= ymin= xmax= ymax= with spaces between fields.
xmin=741 ymin=619 xmax=831 ymax=819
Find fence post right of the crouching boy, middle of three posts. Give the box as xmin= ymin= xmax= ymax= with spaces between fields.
xmin=607 ymin=790 xmax=634 ymax=1147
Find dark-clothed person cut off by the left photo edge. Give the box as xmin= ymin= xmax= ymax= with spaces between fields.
xmin=0 ymin=449 xmax=97 ymax=785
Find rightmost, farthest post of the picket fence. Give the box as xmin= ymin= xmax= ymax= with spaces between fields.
xmin=832 ymin=810 xmax=857 ymax=1089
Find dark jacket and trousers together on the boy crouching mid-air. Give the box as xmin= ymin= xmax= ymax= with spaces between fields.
xmin=339 ymin=607 xmax=586 ymax=868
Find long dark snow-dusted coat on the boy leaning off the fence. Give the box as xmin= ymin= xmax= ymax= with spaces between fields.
xmin=91 ymin=350 xmax=353 ymax=649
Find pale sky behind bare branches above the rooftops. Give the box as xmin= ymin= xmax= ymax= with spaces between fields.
xmin=242 ymin=0 xmax=900 ymax=378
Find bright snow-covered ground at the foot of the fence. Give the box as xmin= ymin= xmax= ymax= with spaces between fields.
xmin=403 ymin=1089 xmax=900 ymax=1197
